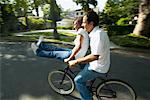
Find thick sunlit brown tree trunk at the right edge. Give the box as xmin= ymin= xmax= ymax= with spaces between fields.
xmin=133 ymin=0 xmax=150 ymax=37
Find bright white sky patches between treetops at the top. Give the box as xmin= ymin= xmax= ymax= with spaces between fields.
xmin=56 ymin=0 xmax=107 ymax=11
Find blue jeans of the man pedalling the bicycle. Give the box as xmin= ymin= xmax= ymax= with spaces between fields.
xmin=74 ymin=64 xmax=106 ymax=100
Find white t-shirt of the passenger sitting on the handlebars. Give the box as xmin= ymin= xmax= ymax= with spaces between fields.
xmin=74 ymin=28 xmax=89 ymax=59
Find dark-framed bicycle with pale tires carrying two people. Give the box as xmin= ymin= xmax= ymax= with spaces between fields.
xmin=48 ymin=66 xmax=136 ymax=100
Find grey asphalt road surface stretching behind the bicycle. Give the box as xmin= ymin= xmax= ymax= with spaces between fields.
xmin=0 ymin=42 xmax=150 ymax=100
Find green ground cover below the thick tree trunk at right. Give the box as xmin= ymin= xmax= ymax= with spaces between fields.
xmin=110 ymin=34 xmax=150 ymax=49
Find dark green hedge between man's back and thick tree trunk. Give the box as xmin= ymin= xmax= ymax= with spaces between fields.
xmin=106 ymin=25 xmax=135 ymax=36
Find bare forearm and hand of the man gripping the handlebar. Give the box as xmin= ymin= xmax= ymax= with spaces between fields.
xmin=68 ymin=54 xmax=99 ymax=67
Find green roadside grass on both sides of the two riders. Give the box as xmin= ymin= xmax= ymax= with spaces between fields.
xmin=1 ymin=32 xmax=150 ymax=49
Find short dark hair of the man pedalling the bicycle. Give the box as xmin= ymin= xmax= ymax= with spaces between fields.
xmin=86 ymin=10 xmax=99 ymax=27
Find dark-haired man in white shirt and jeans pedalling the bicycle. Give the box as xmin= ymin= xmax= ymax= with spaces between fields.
xmin=68 ymin=11 xmax=110 ymax=100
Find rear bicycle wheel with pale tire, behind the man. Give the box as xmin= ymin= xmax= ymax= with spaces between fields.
xmin=96 ymin=79 xmax=136 ymax=100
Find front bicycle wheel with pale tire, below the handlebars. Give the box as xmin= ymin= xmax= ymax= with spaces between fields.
xmin=48 ymin=71 xmax=75 ymax=95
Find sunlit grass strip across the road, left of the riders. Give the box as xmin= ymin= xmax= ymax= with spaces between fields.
xmin=2 ymin=32 xmax=76 ymax=42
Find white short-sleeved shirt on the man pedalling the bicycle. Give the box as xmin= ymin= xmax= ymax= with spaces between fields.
xmin=89 ymin=26 xmax=110 ymax=73
